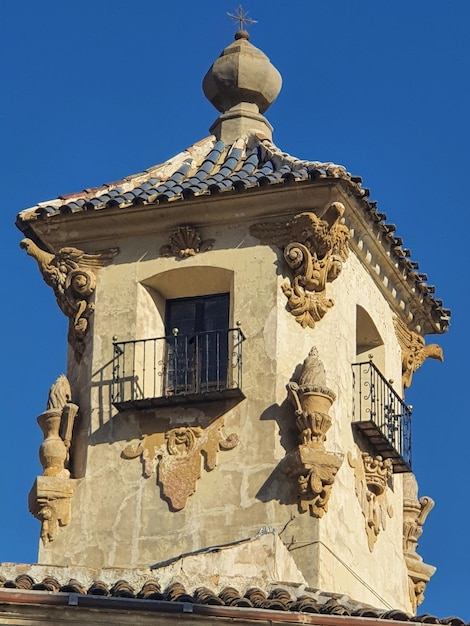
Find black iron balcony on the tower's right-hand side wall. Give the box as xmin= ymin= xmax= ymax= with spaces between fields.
xmin=352 ymin=361 xmax=411 ymax=473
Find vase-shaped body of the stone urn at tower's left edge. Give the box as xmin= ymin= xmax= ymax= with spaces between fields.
xmin=38 ymin=409 xmax=70 ymax=478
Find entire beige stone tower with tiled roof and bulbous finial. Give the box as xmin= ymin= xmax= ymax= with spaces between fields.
xmin=13 ymin=25 xmax=449 ymax=612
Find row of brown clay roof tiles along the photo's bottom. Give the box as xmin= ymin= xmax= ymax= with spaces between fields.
xmin=0 ymin=574 xmax=466 ymax=626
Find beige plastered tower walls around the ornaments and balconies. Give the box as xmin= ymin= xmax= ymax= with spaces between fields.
xmin=35 ymin=210 xmax=409 ymax=610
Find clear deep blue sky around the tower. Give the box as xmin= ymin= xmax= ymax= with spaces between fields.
xmin=0 ymin=0 xmax=470 ymax=621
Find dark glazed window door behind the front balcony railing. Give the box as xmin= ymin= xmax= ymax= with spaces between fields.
xmin=165 ymin=293 xmax=230 ymax=395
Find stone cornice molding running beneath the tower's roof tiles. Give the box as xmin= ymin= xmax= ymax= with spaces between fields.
xmin=18 ymin=178 xmax=450 ymax=335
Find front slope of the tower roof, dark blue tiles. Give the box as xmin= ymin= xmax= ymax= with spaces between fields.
xmin=15 ymin=134 xmax=369 ymax=217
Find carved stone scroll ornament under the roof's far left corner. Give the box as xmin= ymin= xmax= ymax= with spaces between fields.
xmin=20 ymin=239 xmax=119 ymax=360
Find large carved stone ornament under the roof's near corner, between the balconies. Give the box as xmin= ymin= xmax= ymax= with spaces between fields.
xmin=250 ymin=202 xmax=350 ymax=328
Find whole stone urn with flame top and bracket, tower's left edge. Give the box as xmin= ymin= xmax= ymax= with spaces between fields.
xmin=29 ymin=374 xmax=78 ymax=543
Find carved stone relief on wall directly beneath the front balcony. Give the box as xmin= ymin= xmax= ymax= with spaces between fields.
xmin=122 ymin=419 xmax=239 ymax=511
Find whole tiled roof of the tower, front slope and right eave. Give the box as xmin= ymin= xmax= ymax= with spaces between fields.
xmin=17 ymin=133 xmax=450 ymax=332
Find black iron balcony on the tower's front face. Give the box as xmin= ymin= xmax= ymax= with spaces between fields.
xmin=112 ymin=328 xmax=244 ymax=411
